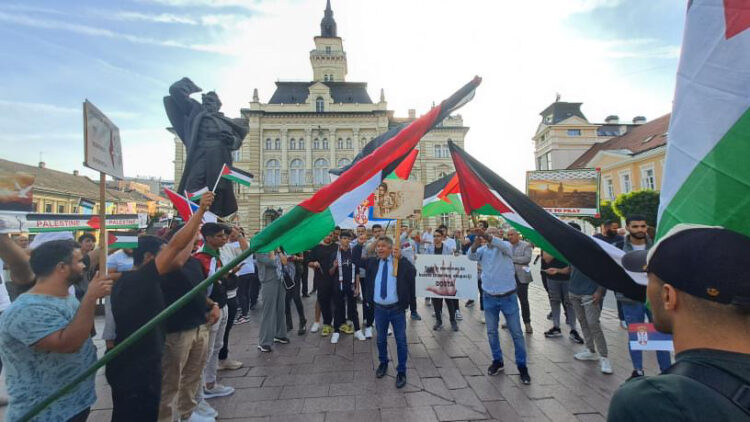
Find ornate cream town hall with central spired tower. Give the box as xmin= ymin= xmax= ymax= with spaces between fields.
xmin=175 ymin=0 xmax=469 ymax=231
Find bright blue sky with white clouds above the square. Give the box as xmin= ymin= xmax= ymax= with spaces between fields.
xmin=0 ymin=0 xmax=686 ymax=188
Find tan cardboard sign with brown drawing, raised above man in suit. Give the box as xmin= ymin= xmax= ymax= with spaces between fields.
xmin=373 ymin=179 xmax=424 ymax=220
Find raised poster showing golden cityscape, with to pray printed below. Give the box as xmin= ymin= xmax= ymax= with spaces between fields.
xmin=526 ymin=169 xmax=601 ymax=217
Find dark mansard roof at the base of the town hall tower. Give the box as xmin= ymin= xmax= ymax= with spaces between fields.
xmin=268 ymin=82 xmax=372 ymax=104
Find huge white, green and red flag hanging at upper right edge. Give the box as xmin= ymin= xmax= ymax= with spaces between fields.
xmin=656 ymin=0 xmax=750 ymax=238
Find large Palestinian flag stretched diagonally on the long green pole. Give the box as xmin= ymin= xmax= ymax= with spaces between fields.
xmin=250 ymin=77 xmax=481 ymax=253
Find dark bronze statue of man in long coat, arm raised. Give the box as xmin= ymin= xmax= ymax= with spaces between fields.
xmin=164 ymin=78 xmax=247 ymax=217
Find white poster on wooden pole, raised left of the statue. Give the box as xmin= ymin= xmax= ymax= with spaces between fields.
xmin=83 ymin=100 xmax=124 ymax=179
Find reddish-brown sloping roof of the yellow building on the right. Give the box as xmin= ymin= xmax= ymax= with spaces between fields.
xmin=568 ymin=114 xmax=670 ymax=169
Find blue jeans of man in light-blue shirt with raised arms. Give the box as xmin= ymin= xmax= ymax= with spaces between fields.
xmin=482 ymin=293 xmax=526 ymax=367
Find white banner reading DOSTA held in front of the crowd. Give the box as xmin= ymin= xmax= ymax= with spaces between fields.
xmin=414 ymin=255 xmax=479 ymax=299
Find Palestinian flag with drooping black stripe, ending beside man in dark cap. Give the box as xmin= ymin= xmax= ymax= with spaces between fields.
xmin=448 ymin=141 xmax=646 ymax=301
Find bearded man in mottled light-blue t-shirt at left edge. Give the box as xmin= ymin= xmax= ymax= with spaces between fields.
xmin=0 ymin=240 xmax=112 ymax=421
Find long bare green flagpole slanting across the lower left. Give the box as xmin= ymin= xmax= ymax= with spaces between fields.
xmin=19 ymin=248 xmax=253 ymax=422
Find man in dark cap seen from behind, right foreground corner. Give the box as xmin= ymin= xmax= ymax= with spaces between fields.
xmin=608 ymin=224 xmax=750 ymax=422
